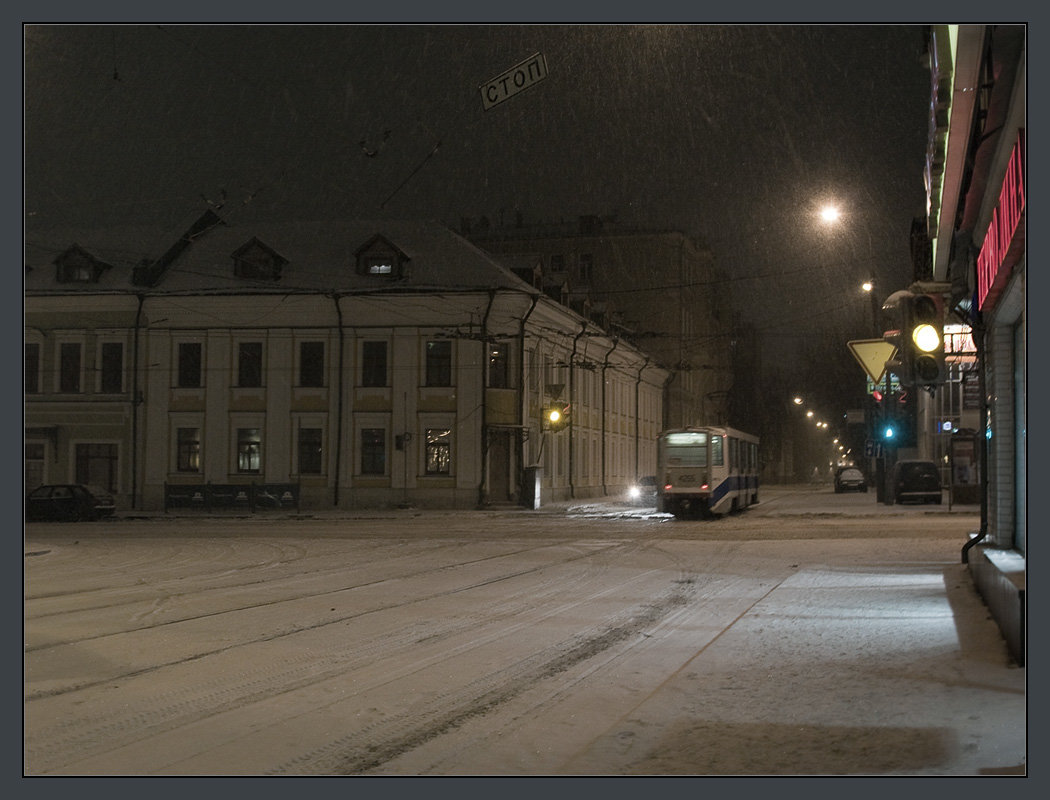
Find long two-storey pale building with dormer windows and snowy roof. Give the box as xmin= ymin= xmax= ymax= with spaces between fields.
xmin=24 ymin=210 xmax=668 ymax=509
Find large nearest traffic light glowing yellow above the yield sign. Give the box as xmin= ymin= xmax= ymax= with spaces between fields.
xmin=882 ymin=289 xmax=947 ymax=386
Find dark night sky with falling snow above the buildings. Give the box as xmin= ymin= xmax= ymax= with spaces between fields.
xmin=24 ymin=24 xmax=929 ymax=417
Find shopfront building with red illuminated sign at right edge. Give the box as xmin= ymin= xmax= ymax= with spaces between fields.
xmin=917 ymin=25 xmax=1027 ymax=664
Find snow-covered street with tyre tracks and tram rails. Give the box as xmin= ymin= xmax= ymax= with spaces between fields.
xmin=24 ymin=487 xmax=1026 ymax=776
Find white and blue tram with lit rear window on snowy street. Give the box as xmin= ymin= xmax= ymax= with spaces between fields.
xmin=656 ymin=426 xmax=758 ymax=520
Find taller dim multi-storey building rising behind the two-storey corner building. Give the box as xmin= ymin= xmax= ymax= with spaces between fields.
xmin=461 ymin=216 xmax=740 ymax=427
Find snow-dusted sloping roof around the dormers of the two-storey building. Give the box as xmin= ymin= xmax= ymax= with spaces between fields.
xmin=24 ymin=216 xmax=534 ymax=294
